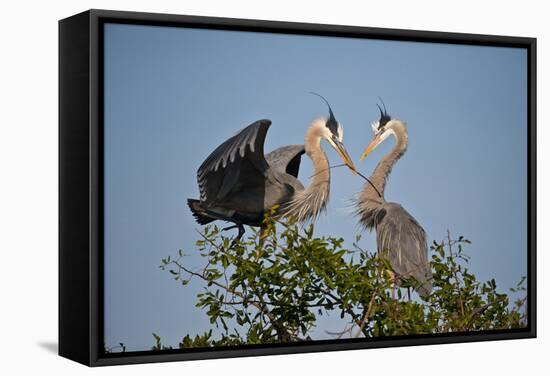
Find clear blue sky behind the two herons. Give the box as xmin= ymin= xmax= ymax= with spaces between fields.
xmin=104 ymin=24 xmax=527 ymax=351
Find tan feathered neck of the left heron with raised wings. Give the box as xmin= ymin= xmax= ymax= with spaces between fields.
xmin=285 ymin=119 xmax=330 ymax=222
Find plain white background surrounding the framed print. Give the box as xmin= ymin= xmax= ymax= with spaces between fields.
xmin=0 ymin=0 xmax=550 ymax=376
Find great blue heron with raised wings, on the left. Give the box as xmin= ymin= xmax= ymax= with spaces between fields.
xmin=187 ymin=94 xmax=355 ymax=239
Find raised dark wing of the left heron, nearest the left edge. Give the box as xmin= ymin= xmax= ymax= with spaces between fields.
xmin=197 ymin=119 xmax=271 ymax=204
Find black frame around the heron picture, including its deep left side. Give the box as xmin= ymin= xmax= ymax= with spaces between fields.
xmin=59 ymin=10 xmax=537 ymax=366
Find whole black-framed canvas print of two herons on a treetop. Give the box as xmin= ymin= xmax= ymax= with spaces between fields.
xmin=59 ymin=10 xmax=536 ymax=366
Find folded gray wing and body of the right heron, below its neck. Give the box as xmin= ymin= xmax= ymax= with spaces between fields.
xmin=376 ymin=203 xmax=432 ymax=295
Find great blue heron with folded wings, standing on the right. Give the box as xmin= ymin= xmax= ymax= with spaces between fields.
xmin=357 ymin=106 xmax=432 ymax=296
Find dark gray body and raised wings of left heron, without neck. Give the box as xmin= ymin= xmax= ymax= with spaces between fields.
xmin=188 ymin=120 xmax=305 ymax=226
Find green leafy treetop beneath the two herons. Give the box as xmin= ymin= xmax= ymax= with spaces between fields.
xmin=153 ymin=217 xmax=527 ymax=350
